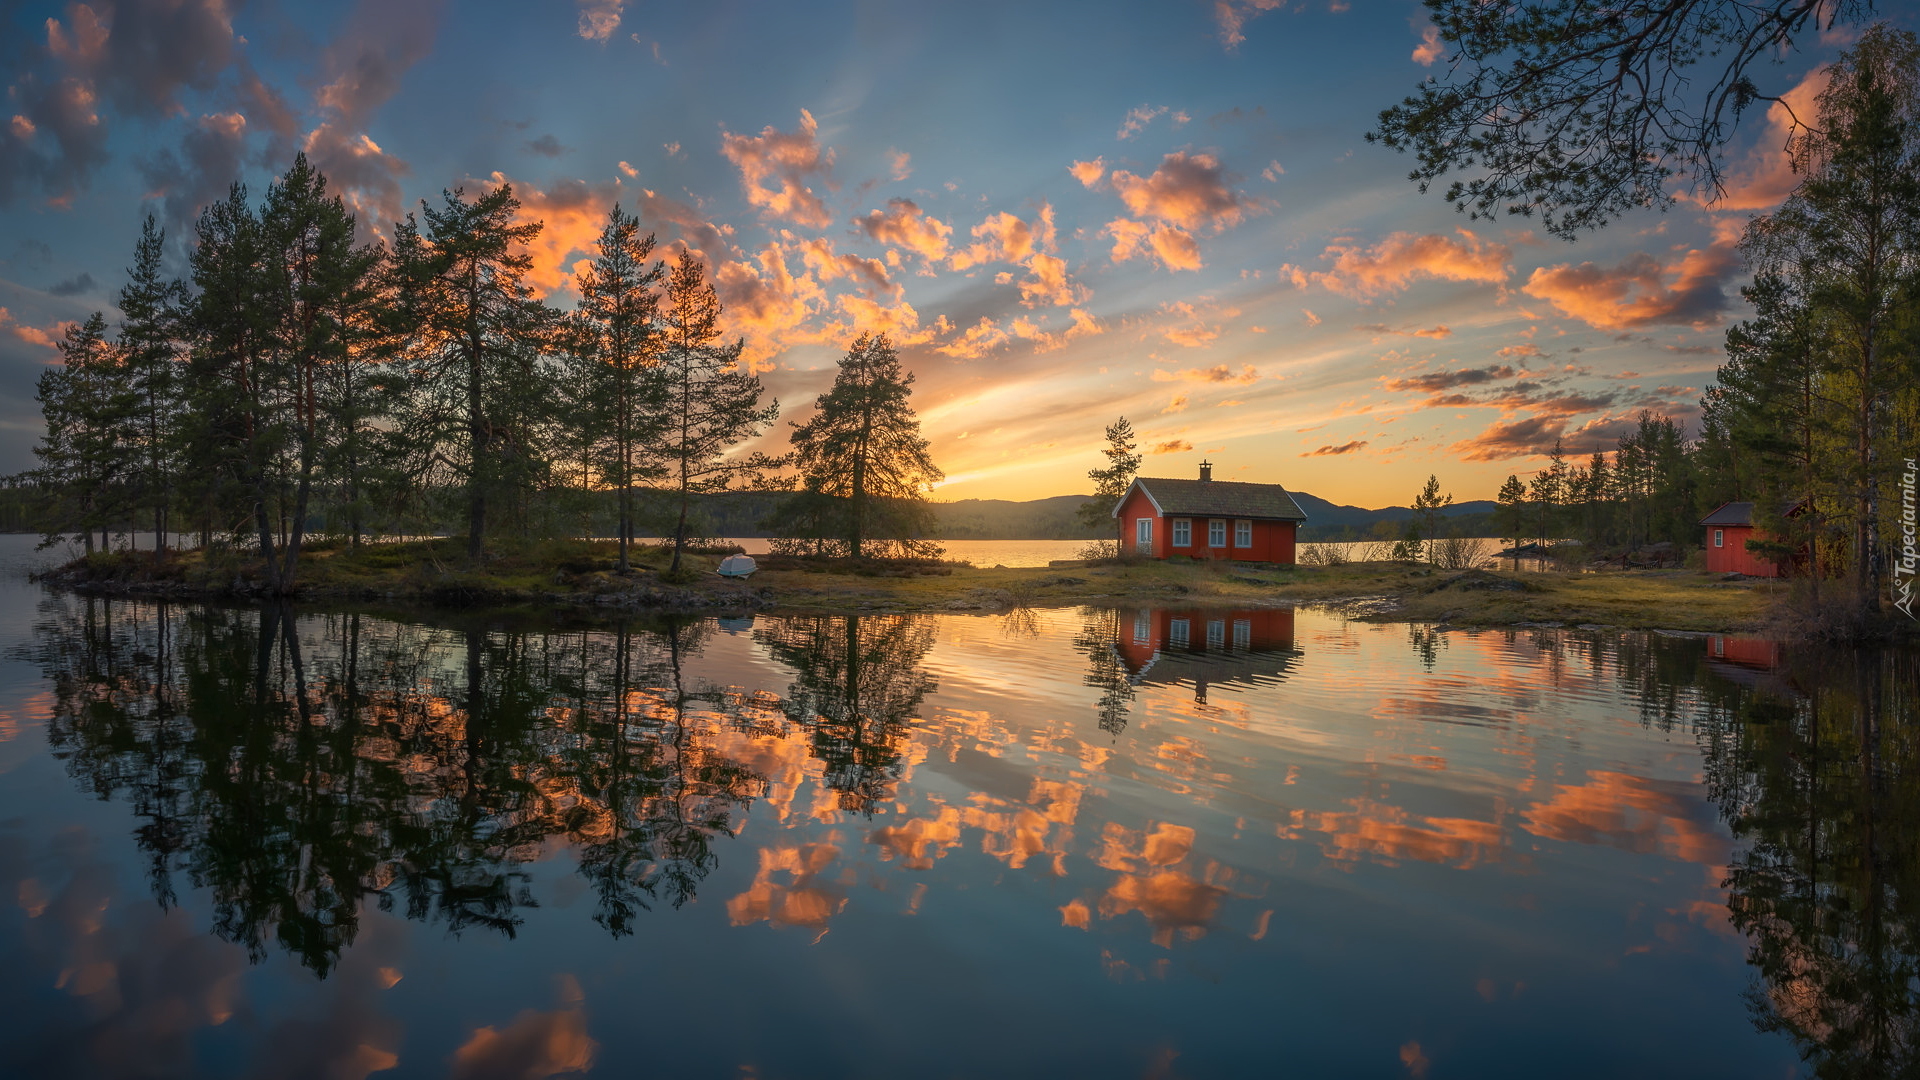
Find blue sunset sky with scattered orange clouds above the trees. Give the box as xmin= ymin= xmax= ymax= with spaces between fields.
xmin=0 ymin=0 xmax=1889 ymax=505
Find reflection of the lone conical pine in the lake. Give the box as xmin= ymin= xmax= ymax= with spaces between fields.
xmin=753 ymin=615 xmax=937 ymax=813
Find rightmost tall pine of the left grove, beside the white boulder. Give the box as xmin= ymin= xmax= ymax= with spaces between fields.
xmin=651 ymin=252 xmax=780 ymax=577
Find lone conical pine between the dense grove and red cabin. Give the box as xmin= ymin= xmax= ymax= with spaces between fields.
xmin=770 ymin=334 xmax=945 ymax=559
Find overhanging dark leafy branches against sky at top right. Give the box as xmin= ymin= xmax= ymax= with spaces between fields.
xmin=1367 ymin=0 xmax=1874 ymax=240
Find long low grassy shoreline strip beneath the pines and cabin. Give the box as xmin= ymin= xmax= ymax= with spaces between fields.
xmin=26 ymin=538 xmax=1784 ymax=632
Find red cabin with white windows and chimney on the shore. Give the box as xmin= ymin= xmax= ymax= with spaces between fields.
xmin=1114 ymin=461 xmax=1308 ymax=563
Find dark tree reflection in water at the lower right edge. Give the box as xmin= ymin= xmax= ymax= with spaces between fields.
xmin=1705 ymin=651 xmax=1920 ymax=1078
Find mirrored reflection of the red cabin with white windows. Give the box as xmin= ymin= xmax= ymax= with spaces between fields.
xmin=1114 ymin=607 xmax=1300 ymax=701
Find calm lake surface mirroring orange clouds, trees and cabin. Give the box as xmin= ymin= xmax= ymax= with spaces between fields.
xmin=0 ymin=538 xmax=1920 ymax=1078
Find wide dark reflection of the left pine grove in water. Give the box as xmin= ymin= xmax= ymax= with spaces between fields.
xmin=33 ymin=600 xmax=764 ymax=976
